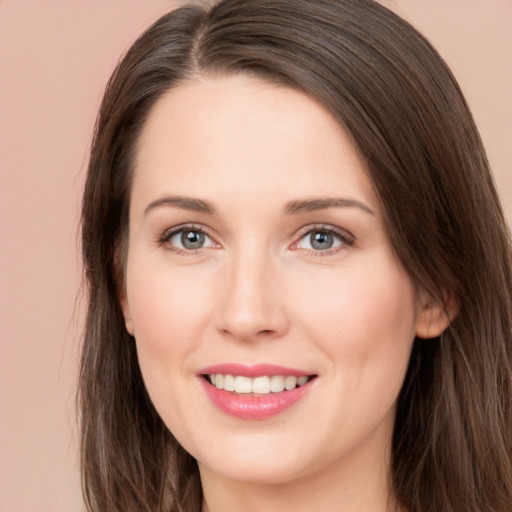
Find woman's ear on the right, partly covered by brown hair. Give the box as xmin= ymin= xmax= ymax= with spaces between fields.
xmin=416 ymin=291 xmax=459 ymax=339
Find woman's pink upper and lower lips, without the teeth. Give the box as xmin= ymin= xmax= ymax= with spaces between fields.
xmin=197 ymin=364 xmax=316 ymax=420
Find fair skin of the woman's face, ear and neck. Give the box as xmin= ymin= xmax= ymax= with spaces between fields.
xmin=122 ymin=76 xmax=448 ymax=512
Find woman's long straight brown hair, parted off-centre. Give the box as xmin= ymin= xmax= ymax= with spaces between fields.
xmin=78 ymin=0 xmax=512 ymax=512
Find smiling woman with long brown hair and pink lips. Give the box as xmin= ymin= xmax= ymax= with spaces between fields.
xmin=79 ymin=0 xmax=512 ymax=512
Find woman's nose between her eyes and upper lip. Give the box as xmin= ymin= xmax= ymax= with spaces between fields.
xmin=217 ymin=246 xmax=289 ymax=341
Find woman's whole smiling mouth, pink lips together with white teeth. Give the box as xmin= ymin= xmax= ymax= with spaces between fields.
xmin=197 ymin=364 xmax=318 ymax=420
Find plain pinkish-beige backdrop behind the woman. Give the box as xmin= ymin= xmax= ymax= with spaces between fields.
xmin=0 ymin=0 xmax=512 ymax=512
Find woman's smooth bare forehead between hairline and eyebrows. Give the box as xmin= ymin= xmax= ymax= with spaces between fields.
xmin=134 ymin=75 xmax=376 ymax=213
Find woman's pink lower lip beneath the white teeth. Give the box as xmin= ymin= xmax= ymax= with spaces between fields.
xmin=201 ymin=377 xmax=316 ymax=420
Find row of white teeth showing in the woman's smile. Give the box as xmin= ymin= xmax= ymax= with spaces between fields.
xmin=207 ymin=373 xmax=309 ymax=395
